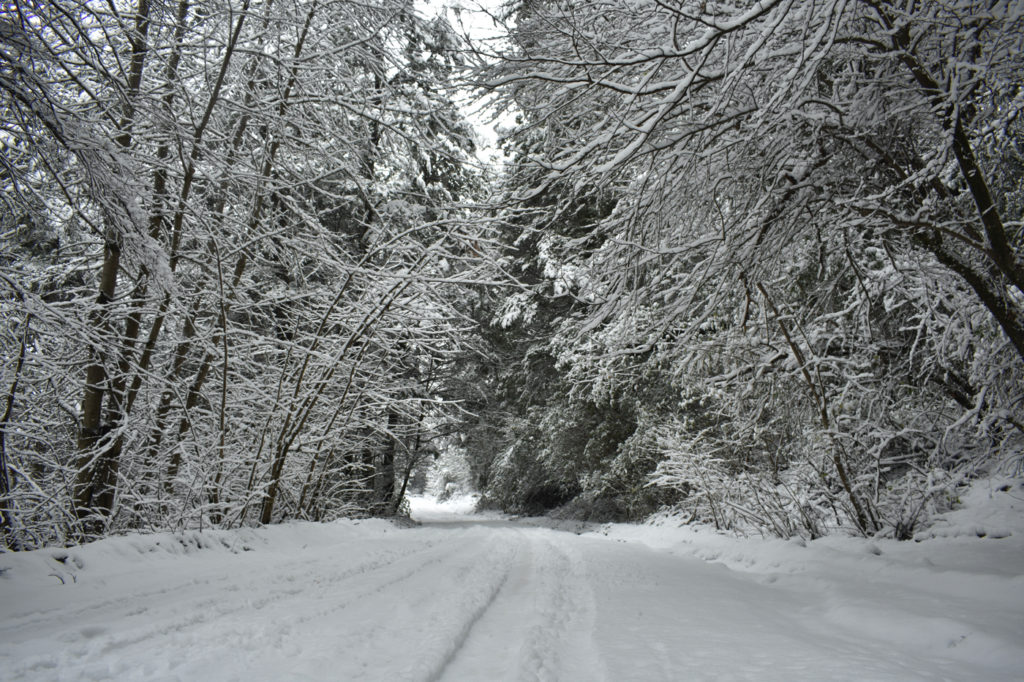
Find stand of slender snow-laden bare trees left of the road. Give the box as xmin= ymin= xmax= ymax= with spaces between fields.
xmin=0 ymin=0 xmax=490 ymax=546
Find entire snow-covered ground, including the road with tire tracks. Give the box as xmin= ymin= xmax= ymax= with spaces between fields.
xmin=0 ymin=482 xmax=1024 ymax=682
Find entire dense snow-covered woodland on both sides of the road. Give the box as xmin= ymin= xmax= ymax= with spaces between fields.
xmin=0 ymin=0 xmax=1024 ymax=550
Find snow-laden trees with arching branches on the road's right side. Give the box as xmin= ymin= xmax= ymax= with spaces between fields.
xmin=478 ymin=0 xmax=1024 ymax=537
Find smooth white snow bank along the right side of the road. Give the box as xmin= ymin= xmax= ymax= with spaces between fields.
xmin=597 ymin=479 xmax=1024 ymax=670
